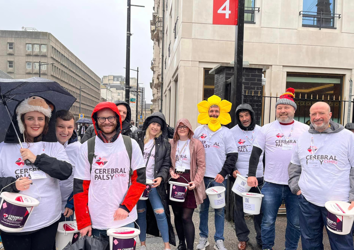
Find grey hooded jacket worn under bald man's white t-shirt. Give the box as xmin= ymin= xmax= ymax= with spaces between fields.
xmin=288 ymin=121 xmax=354 ymax=201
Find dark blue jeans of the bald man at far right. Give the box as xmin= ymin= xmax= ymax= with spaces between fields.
xmin=298 ymin=194 xmax=353 ymax=250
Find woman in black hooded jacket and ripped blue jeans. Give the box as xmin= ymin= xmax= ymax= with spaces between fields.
xmin=133 ymin=112 xmax=175 ymax=250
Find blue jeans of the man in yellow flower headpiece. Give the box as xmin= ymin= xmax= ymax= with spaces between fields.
xmin=199 ymin=177 xmax=227 ymax=242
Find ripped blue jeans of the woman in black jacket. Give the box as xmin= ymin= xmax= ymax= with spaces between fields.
xmin=137 ymin=188 xmax=169 ymax=243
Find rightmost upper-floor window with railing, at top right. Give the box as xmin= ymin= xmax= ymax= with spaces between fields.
xmin=300 ymin=0 xmax=340 ymax=29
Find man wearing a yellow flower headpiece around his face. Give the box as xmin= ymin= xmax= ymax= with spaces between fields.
xmin=193 ymin=95 xmax=237 ymax=250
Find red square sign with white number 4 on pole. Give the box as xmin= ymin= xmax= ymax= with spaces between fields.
xmin=213 ymin=0 xmax=238 ymax=25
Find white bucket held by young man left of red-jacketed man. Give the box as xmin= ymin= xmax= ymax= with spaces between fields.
xmin=55 ymin=221 xmax=80 ymax=250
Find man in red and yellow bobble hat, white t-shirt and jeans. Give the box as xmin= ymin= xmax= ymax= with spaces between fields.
xmin=247 ymin=88 xmax=308 ymax=250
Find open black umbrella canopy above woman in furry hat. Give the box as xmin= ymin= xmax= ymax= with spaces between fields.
xmin=0 ymin=77 xmax=76 ymax=143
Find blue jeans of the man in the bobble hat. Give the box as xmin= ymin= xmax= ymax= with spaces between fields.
xmin=261 ymin=182 xmax=300 ymax=250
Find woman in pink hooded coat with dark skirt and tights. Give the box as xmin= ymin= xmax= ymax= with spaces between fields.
xmin=170 ymin=119 xmax=206 ymax=250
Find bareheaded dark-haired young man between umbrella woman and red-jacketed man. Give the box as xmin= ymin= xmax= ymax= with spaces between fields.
xmin=55 ymin=110 xmax=81 ymax=221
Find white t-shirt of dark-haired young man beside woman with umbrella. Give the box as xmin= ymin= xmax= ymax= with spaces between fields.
xmin=59 ymin=141 xmax=81 ymax=213
